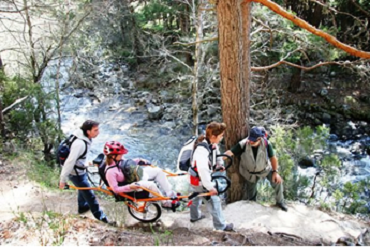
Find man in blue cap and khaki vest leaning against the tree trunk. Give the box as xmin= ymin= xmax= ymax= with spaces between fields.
xmin=225 ymin=127 xmax=288 ymax=211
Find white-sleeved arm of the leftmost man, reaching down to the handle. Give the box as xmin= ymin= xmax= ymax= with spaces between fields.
xmin=59 ymin=139 xmax=86 ymax=189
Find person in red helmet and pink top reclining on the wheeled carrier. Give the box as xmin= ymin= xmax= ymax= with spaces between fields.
xmin=98 ymin=141 xmax=179 ymax=209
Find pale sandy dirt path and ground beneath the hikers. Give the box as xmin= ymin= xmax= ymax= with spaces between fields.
xmin=0 ymin=157 xmax=370 ymax=246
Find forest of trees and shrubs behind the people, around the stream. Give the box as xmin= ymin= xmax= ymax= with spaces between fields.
xmin=0 ymin=0 xmax=370 ymax=231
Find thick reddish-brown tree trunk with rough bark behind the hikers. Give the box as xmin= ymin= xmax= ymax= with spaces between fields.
xmin=217 ymin=0 xmax=252 ymax=202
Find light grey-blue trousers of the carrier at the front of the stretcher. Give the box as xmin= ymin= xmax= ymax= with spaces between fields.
xmin=190 ymin=186 xmax=226 ymax=230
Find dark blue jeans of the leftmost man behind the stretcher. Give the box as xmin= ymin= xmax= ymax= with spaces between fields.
xmin=69 ymin=173 xmax=106 ymax=220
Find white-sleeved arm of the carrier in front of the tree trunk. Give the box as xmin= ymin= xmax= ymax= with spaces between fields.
xmin=193 ymin=146 xmax=214 ymax=191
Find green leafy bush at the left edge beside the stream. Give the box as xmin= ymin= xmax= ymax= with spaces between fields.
xmin=1 ymin=72 xmax=58 ymax=162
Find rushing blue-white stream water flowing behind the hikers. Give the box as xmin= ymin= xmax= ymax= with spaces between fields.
xmin=54 ymin=61 xmax=370 ymax=202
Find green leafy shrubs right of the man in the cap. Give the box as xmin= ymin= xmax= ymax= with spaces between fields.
xmin=268 ymin=126 xmax=370 ymax=217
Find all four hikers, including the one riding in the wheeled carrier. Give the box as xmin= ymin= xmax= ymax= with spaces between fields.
xmin=59 ymin=120 xmax=287 ymax=231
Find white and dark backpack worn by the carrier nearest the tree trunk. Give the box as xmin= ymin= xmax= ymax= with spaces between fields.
xmin=177 ymin=136 xmax=211 ymax=171
